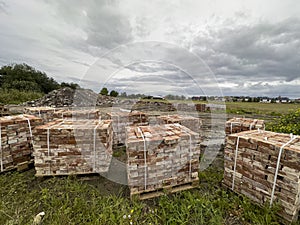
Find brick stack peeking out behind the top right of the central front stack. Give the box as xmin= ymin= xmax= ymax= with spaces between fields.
xmin=157 ymin=115 xmax=202 ymax=133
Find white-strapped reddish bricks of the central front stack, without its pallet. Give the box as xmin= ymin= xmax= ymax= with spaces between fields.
xmin=126 ymin=124 xmax=200 ymax=200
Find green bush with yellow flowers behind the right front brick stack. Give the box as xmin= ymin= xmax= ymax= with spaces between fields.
xmin=267 ymin=109 xmax=300 ymax=135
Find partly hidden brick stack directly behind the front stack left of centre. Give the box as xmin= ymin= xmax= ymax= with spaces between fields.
xmin=53 ymin=109 xmax=100 ymax=120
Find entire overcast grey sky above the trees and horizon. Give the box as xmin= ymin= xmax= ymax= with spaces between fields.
xmin=0 ymin=0 xmax=300 ymax=98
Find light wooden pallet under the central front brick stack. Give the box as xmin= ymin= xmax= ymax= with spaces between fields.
xmin=130 ymin=179 xmax=199 ymax=200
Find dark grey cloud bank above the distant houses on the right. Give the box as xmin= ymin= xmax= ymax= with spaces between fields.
xmin=188 ymin=18 xmax=300 ymax=86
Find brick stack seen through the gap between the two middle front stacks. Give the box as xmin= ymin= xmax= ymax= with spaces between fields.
xmin=106 ymin=111 xmax=149 ymax=145
